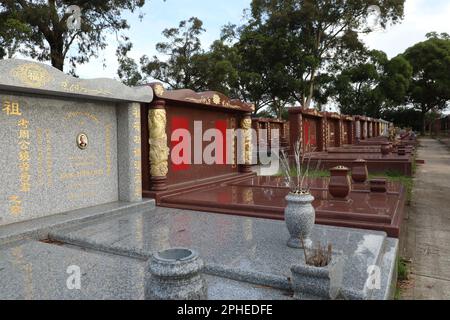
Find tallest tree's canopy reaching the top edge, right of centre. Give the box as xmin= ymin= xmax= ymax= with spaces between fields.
xmin=244 ymin=0 xmax=404 ymax=107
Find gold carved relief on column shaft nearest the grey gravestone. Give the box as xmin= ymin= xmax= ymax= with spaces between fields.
xmin=148 ymin=109 xmax=169 ymax=177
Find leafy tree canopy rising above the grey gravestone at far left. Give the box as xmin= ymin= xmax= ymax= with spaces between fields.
xmin=0 ymin=0 xmax=145 ymax=71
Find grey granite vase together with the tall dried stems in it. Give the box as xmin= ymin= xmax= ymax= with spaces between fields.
xmin=280 ymin=141 xmax=320 ymax=249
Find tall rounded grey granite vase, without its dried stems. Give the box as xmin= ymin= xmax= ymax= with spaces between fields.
xmin=284 ymin=192 xmax=316 ymax=249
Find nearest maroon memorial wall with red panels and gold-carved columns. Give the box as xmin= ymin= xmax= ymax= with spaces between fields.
xmin=141 ymin=84 xmax=253 ymax=197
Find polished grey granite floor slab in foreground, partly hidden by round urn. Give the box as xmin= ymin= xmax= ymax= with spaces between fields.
xmin=0 ymin=241 xmax=292 ymax=300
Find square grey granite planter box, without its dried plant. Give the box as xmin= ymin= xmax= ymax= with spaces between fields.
xmin=291 ymin=256 xmax=344 ymax=300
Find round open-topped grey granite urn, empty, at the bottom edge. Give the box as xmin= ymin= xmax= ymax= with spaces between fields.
xmin=145 ymin=248 xmax=207 ymax=300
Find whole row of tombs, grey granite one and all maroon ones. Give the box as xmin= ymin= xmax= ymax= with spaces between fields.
xmin=0 ymin=60 xmax=416 ymax=238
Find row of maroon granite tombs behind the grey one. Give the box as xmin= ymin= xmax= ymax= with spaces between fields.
xmin=141 ymin=84 xmax=415 ymax=237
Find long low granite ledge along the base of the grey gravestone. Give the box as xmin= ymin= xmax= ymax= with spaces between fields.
xmin=0 ymin=199 xmax=155 ymax=245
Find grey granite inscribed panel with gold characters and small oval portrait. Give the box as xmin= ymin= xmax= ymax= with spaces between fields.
xmin=0 ymin=92 xmax=118 ymax=225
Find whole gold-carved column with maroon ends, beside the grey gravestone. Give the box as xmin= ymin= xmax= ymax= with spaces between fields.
xmin=148 ymin=100 xmax=169 ymax=191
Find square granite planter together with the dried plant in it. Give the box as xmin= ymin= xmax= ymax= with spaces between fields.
xmin=291 ymin=243 xmax=344 ymax=300
